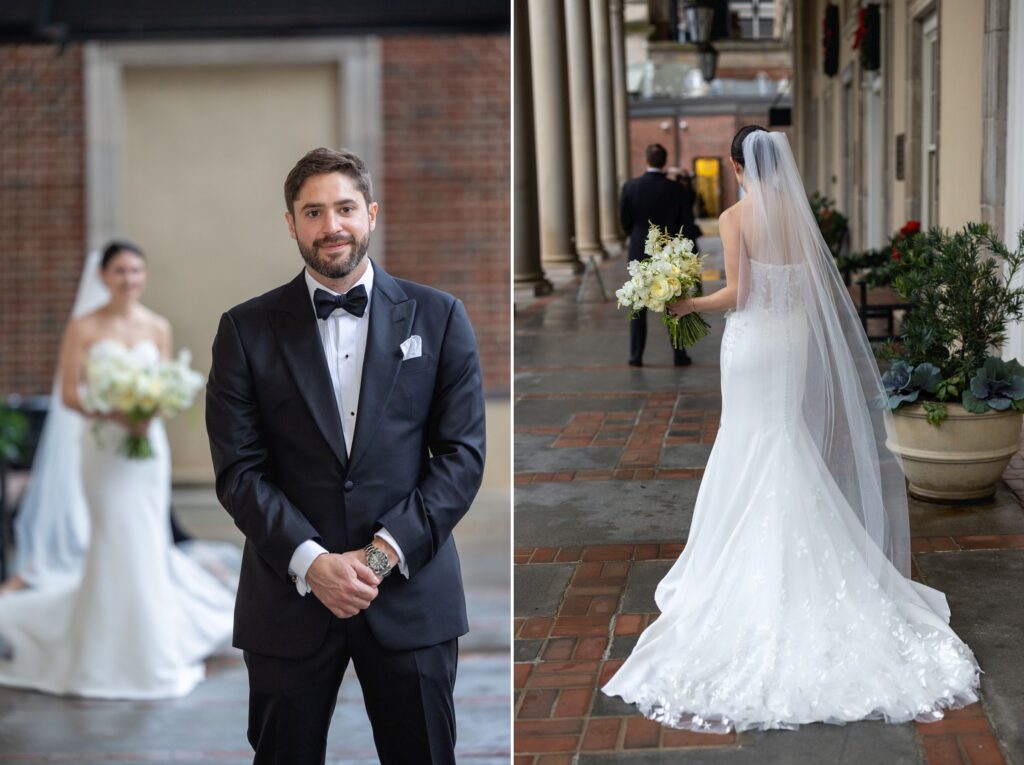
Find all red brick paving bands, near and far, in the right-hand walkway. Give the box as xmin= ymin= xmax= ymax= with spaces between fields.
xmin=513 ymin=252 xmax=1024 ymax=765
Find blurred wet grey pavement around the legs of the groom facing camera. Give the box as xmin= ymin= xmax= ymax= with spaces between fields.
xmin=0 ymin=488 xmax=511 ymax=765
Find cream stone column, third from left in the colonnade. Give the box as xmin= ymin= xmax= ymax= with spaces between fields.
xmin=565 ymin=0 xmax=606 ymax=258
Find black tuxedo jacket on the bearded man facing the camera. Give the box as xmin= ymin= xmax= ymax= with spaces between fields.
xmin=206 ymin=264 xmax=484 ymax=658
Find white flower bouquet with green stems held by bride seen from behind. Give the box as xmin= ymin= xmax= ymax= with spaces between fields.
xmin=615 ymin=223 xmax=711 ymax=349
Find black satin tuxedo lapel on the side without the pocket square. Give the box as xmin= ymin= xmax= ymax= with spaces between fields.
xmin=270 ymin=273 xmax=348 ymax=466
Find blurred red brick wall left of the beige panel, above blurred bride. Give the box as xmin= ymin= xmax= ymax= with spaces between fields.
xmin=0 ymin=45 xmax=85 ymax=395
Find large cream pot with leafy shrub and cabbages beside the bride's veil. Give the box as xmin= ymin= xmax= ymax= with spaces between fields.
xmin=881 ymin=223 xmax=1024 ymax=502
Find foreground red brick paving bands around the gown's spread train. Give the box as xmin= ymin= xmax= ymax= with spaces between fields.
xmin=513 ymin=535 xmax=1024 ymax=765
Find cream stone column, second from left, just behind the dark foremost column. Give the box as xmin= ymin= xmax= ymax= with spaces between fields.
xmin=527 ymin=0 xmax=583 ymax=272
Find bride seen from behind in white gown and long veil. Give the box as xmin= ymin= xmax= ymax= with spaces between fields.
xmin=602 ymin=126 xmax=979 ymax=732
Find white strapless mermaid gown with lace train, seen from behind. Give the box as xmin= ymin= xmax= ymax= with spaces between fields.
xmin=603 ymin=260 xmax=979 ymax=732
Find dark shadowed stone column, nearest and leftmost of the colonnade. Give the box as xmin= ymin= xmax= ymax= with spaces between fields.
xmin=512 ymin=0 xmax=551 ymax=295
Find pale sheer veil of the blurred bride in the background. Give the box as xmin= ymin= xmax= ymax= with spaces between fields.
xmin=14 ymin=252 xmax=110 ymax=587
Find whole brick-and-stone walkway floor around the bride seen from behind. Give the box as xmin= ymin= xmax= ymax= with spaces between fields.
xmin=514 ymin=239 xmax=1024 ymax=765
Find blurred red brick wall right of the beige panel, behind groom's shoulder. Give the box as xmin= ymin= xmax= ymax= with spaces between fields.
xmin=383 ymin=35 xmax=511 ymax=393
